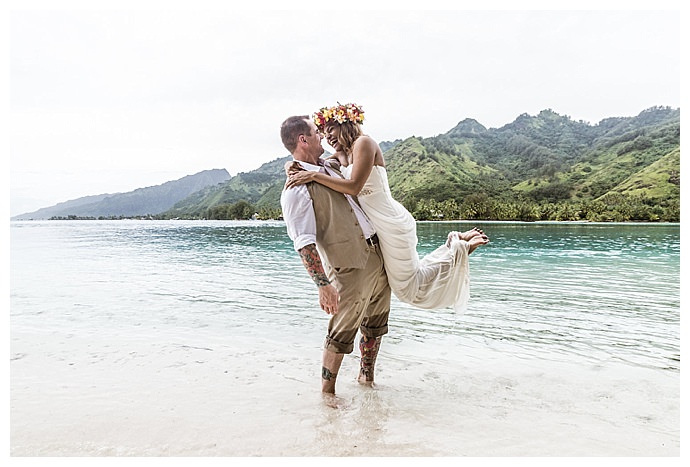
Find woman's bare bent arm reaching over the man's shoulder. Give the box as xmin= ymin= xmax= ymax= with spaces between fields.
xmin=285 ymin=136 xmax=377 ymax=195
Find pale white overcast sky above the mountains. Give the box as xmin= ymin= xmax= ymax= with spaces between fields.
xmin=8 ymin=1 xmax=681 ymax=215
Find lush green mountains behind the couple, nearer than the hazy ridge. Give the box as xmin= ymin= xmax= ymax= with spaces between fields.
xmin=165 ymin=107 xmax=680 ymax=221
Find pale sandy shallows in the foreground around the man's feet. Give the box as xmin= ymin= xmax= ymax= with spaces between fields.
xmin=10 ymin=331 xmax=680 ymax=457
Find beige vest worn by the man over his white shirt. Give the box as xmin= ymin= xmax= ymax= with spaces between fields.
xmin=307 ymin=182 xmax=369 ymax=269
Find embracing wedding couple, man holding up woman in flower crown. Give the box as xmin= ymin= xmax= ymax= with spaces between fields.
xmin=281 ymin=104 xmax=489 ymax=395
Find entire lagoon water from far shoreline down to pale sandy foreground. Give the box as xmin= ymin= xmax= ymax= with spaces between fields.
xmin=10 ymin=221 xmax=680 ymax=456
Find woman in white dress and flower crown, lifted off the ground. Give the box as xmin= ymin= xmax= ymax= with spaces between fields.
xmin=286 ymin=104 xmax=489 ymax=313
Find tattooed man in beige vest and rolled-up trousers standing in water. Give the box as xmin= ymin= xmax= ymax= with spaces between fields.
xmin=280 ymin=115 xmax=391 ymax=394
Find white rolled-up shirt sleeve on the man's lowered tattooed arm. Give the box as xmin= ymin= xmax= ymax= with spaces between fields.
xmin=280 ymin=185 xmax=316 ymax=251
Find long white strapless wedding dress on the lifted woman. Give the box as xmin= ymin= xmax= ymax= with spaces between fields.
xmin=342 ymin=165 xmax=470 ymax=313
